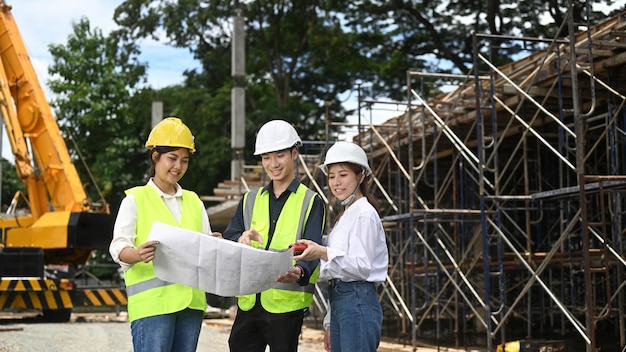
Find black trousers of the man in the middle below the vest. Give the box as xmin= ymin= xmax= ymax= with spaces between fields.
xmin=228 ymin=299 xmax=304 ymax=352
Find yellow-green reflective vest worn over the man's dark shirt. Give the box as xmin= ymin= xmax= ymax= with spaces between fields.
xmin=237 ymin=185 xmax=319 ymax=313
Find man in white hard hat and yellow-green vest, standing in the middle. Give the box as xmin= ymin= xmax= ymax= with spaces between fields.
xmin=224 ymin=120 xmax=326 ymax=352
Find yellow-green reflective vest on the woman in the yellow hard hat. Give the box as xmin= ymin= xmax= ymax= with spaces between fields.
xmin=124 ymin=186 xmax=206 ymax=321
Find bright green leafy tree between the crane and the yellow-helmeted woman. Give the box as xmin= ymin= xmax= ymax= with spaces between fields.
xmin=48 ymin=18 xmax=150 ymax=206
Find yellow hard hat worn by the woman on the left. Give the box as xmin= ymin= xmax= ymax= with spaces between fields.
xmin=146 ymin=117 xmax=196 ymax=153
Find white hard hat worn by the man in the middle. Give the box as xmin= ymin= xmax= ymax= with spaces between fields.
xmin=254 ymin=120 xmax=302 ymax=155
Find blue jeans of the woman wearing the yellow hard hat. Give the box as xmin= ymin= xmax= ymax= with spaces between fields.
xmin=130 ymin=308 xmax=204 ymax=352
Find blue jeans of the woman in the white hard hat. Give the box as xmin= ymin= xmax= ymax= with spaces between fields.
xmin=328 ymin=281 xmax=383 ymax=352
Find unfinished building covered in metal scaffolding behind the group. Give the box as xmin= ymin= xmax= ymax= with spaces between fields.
xmin=212 ymin=3 xmax=626 ymax=351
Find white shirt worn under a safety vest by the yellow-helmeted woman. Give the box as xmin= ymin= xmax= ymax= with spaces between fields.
xmin=109 ymin=179 xmax=212 ymax=271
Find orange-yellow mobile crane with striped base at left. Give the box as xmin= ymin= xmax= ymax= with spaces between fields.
xmin=0 ymin=0 xmax=125 ymax=321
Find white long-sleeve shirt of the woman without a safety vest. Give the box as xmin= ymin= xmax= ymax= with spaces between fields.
xmin=319 ymin=197 xmax=389 ymax=283
